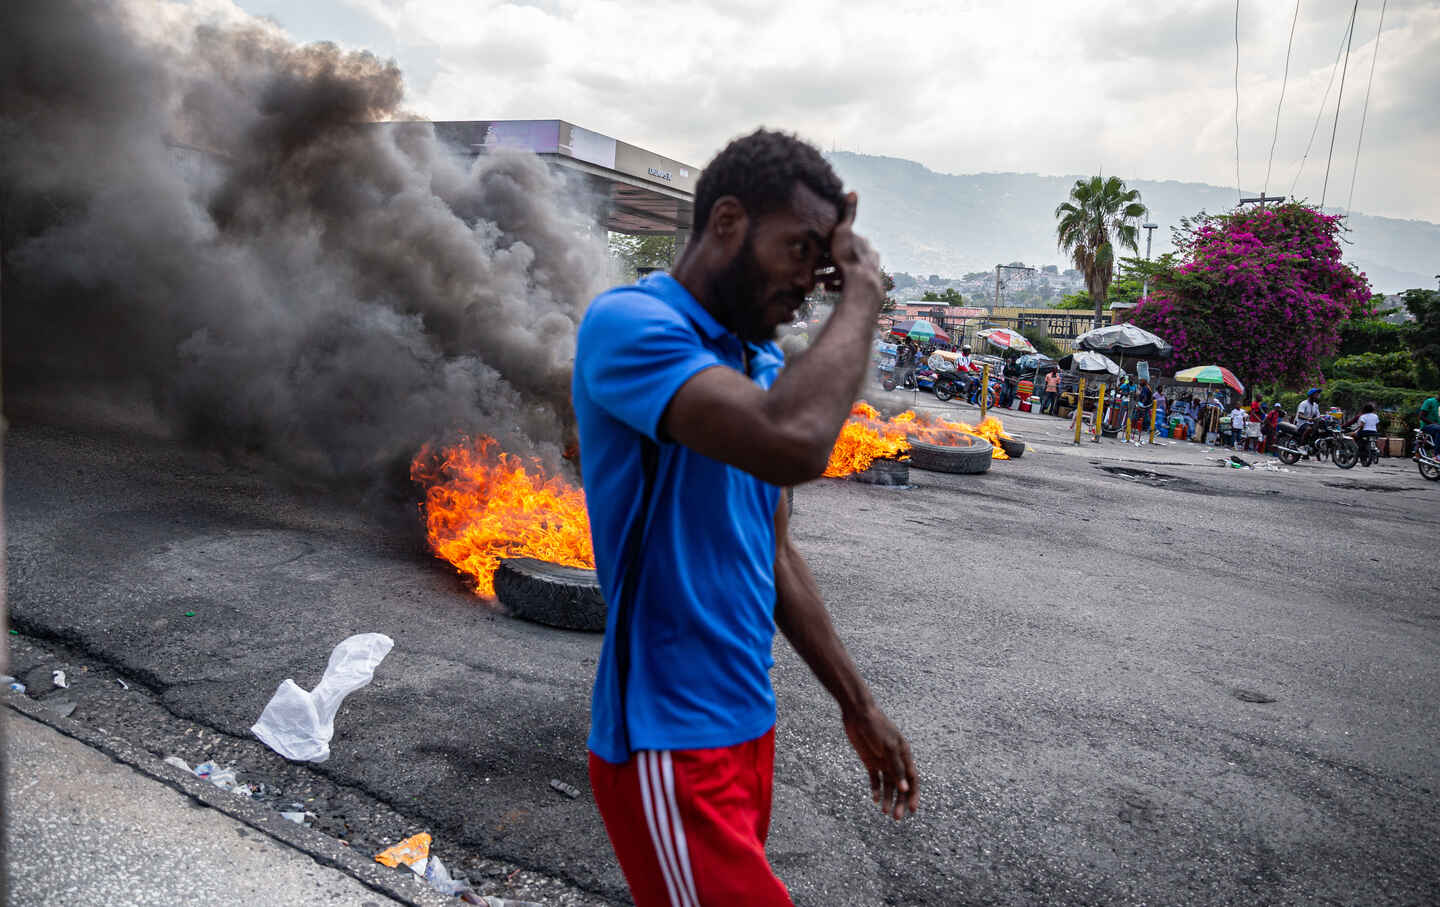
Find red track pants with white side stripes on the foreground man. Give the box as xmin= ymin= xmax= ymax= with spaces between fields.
xmin=590 ymin=728 xmax=791 ymax=907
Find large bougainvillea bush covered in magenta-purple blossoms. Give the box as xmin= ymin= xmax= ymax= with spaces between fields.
xmin=1130 ymin=204 xmax=1371 ymax=387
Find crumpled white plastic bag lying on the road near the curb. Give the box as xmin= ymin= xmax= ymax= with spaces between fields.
xmin=251 ymin=633 xmax=395 ymax=762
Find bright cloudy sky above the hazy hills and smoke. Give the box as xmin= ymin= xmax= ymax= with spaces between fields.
xmin=236 ymin=0 xmax=1440 ymax=222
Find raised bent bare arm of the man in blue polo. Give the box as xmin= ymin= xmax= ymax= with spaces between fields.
xmin=662 ymin=193 xmax=884 ymax=485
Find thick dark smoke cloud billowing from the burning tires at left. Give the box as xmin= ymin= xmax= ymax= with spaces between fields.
xmin=0 ymin=0 xmax=606 ymax=477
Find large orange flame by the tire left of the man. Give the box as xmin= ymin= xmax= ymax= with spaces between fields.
xmin=410 ymin=438 xmax=595 ymax=599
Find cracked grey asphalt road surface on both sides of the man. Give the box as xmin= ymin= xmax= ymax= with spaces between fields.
xmin=6 ymin=394 xmax=1440 ymax=906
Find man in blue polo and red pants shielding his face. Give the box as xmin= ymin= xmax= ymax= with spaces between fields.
xmin=572 ymin=131 xmax=919 ymax=907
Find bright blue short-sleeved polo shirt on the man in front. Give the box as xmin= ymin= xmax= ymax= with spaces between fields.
xmin=572 ymin=274 xmax=783 ymax=763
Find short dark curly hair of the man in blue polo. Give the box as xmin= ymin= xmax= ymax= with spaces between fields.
xmin=694 ymin=130 xmax=845 ymax=233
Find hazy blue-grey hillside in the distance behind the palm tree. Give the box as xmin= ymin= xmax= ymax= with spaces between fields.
xmin=827 ymin=151 xmax=1440 ymax=292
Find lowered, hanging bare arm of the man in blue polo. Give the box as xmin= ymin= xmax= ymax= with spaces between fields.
xmin=775 ymin=495 xmax=920 ymax=819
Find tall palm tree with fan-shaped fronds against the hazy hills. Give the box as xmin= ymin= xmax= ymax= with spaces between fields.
xmin=1056 ymin=176 xmax=1145 ymax=327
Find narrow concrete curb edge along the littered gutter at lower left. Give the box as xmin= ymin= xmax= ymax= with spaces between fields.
xmin=4 ymin=691 xmax=455 ymax=907
